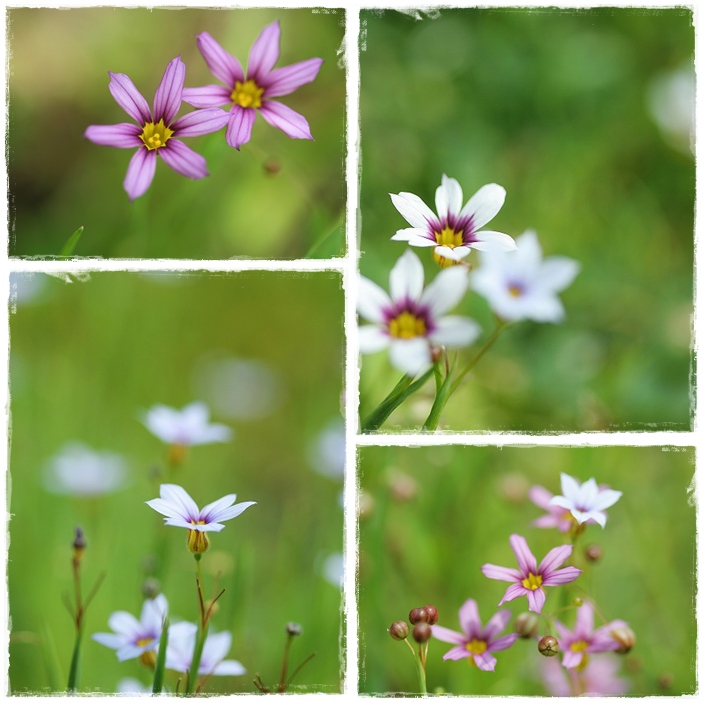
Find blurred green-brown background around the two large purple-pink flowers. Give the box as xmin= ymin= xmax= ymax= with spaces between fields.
xmin=8 ymin=8 xmax=346 ymax=259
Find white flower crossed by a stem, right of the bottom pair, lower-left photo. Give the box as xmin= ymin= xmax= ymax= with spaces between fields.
xmin=166 ymin=622 xmax=247 ymax=676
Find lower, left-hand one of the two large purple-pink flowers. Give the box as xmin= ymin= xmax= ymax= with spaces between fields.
xmin=85 ymin=56 xmax=228 ymax=200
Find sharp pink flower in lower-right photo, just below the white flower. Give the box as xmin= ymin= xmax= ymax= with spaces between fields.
xmin=481 ymin=535 xmax=581 ymax=613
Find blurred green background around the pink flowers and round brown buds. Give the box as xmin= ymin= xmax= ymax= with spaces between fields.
xmin=359 ymin=446 xmax=696 ymax=696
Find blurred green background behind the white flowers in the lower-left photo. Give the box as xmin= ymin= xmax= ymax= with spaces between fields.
xmin=8 ymin=272 xmax=344 ymax=693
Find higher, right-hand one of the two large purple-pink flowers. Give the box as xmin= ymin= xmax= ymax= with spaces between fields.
xmin=183 ymin=20 xmax=322 ymax=149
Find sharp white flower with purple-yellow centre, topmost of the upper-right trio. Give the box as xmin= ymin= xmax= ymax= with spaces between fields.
xmin=391 ymin=175 xmax=515 ymax=267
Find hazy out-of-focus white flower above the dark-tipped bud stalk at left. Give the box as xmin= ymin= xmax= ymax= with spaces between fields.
xmin=44 ymin=442 xmax=127 ymax=498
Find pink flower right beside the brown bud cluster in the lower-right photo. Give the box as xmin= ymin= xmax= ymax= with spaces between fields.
xmin=432 ymin=598 xmax=518 ymax=671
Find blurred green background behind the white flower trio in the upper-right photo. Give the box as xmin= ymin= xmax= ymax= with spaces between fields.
xmin=360 ymin=8 xmax=695 ymax=431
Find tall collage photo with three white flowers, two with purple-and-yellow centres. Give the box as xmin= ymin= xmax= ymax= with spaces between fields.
xmin=358 ymin=7 xmax=695 ymax=433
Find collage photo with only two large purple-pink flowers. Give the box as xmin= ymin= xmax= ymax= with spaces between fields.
xmin=7 ymin=7 xmax=346 ymax=260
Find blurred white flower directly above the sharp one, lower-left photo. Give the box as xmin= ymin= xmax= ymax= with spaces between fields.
xmin=142 ymin=403 xmax=233 ymax=447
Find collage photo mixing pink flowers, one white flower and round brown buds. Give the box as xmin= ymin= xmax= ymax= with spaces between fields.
xmin=358 ymin=446 xmax=697 ymax=697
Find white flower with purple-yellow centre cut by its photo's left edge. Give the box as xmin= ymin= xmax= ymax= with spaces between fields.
xmin=358 ymin=250 xmax=481 ymax=375
